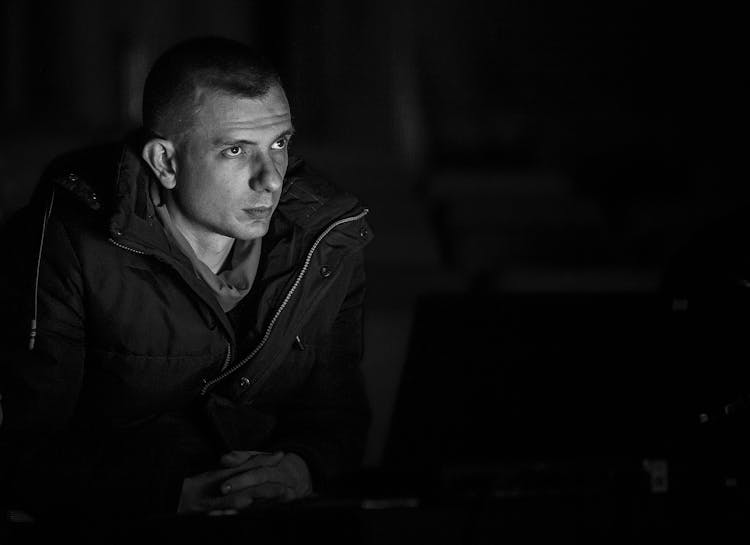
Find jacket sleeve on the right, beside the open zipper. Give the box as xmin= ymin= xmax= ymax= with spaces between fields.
xmin=271 ymin=252 xmax=371 ymax=493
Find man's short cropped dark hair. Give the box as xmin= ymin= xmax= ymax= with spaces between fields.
xmin=143 ymin=36 xmax=281 ymax=137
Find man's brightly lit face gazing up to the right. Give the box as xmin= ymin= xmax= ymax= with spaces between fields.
xmin=173 ymin=86 xmax=293 ymax=240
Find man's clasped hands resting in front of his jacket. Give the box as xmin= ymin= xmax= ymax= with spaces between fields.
xmin=177 ymin=450 xmax=312 ymax=515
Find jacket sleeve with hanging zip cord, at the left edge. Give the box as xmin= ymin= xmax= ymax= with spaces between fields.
xmin=0 ymin=197 xmax=187 ymax=520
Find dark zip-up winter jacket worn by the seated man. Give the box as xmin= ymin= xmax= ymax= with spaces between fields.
xmin=0 ymin=133 xmax=371 ymax=517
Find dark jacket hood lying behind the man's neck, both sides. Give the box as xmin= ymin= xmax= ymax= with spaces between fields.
xmin=39 ymin=130 xmax=372 ymax=251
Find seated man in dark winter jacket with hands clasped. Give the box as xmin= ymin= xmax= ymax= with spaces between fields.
xmin=0 ymin=38 xmax=371 ymax=519
